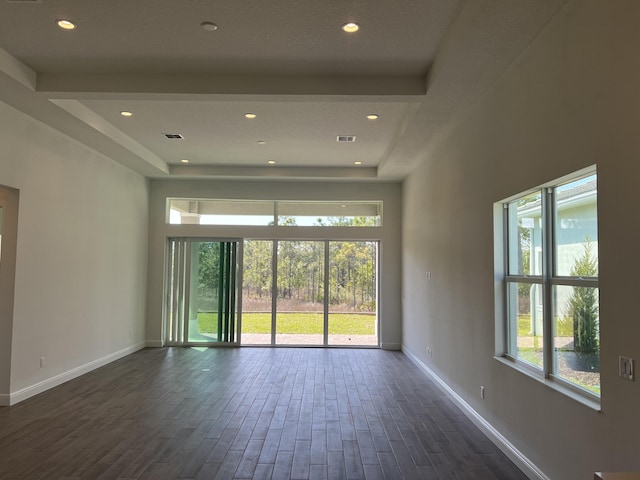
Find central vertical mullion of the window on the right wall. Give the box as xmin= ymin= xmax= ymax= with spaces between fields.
xmin=542 ymin=188 xmax=556 ymax=378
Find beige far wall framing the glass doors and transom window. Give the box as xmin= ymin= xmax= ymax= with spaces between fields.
xmin=147 ymin=180 xmax=402 ymax=349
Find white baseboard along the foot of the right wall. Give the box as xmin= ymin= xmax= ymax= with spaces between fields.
xmin=402 ymin=345 xmax=550 ymax=480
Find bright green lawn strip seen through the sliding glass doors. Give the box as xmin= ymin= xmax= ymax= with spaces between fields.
xmin=198 ymin=312 xmax=376 ymax=335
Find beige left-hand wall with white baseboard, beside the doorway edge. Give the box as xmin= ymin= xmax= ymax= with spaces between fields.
xmin=0 ymin=99 xmax=148 ymax=402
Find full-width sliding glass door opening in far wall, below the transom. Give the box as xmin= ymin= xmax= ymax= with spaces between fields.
xmin=164 ymin=238 xmax=379 ymax=347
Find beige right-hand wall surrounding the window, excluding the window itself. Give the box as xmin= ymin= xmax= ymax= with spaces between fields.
xmin=402 ymin=0 xmax=640 ymax=480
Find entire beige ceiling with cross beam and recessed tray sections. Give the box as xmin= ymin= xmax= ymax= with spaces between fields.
xmin=0 ymin=0 xmax=565 ymax=181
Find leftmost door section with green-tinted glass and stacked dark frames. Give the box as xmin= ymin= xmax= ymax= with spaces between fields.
xmin=165 ymin=239 xmax=240 ymax=345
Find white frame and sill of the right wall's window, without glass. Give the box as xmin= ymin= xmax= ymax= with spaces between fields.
xmin=494 ymin=166 xmax=600 ymax=410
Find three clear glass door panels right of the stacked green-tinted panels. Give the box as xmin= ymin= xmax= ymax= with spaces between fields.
xmin=242 ymin=240 xmax=378 ymax=346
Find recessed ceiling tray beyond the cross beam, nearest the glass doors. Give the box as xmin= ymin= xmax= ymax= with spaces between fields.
xmin=82 ymin=100 xmax=416 ymax=167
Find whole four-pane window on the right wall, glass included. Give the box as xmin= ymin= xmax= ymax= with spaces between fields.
xmin=499 ymin=169 xmax=600 ymax=400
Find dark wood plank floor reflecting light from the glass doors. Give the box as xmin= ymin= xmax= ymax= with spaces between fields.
xmin=0 ymin=347 xmax=526 ymax=480
